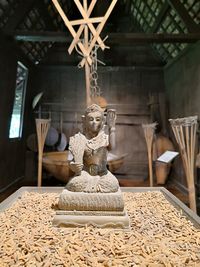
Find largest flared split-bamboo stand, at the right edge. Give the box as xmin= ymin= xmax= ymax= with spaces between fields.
xmin=169 ymin=116 xmax=198 ymax=212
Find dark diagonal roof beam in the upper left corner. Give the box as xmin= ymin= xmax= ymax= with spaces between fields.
xmin=3 ymin=0 xmax=38 ymax=33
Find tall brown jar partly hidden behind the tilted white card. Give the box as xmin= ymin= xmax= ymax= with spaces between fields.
xmin=153 ymin=134 xmax=175 ymax=185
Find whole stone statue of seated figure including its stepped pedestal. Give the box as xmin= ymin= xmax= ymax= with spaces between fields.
xmin=53 ymin=104 xmax=130 ymax=229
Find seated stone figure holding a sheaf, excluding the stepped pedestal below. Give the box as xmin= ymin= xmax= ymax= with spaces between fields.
xmin=66 ymin=104 xmax=119 ymax=193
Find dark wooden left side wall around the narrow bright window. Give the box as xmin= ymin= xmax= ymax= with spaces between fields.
xmin=0 ymin=36 xmax=35 ymax=192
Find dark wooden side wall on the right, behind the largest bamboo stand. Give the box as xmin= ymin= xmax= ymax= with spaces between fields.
xmin=164 ymin=43 xmax=200 ymax=193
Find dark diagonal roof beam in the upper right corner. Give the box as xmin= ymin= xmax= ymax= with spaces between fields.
xmin=167 ymin=0 xmax=200 ymax=32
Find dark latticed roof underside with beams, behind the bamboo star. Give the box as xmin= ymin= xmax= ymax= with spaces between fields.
xmin=0 ymin=0 xmax=200 ymax=65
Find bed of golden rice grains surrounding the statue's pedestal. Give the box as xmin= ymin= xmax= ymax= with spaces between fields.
xmin=0 ymin=191 xmax=200 ymax=267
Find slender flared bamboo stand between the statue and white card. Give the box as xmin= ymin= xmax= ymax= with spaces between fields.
xmin=142 ymin=122 xmax=157 ymax=187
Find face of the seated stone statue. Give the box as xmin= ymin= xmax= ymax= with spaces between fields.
xmin=86 ymin=111 xmax=103 ymax=133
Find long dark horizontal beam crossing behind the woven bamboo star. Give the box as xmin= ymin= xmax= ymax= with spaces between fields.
xmin=9 ymin=31 xmax=200 ymax=45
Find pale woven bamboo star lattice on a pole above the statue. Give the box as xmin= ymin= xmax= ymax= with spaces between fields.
xmin=52 ymin=0 xmax=117 ymax=106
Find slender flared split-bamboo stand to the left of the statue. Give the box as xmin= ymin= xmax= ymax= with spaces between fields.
xmin=35 ymin=119 xmax=50 ymax=186
